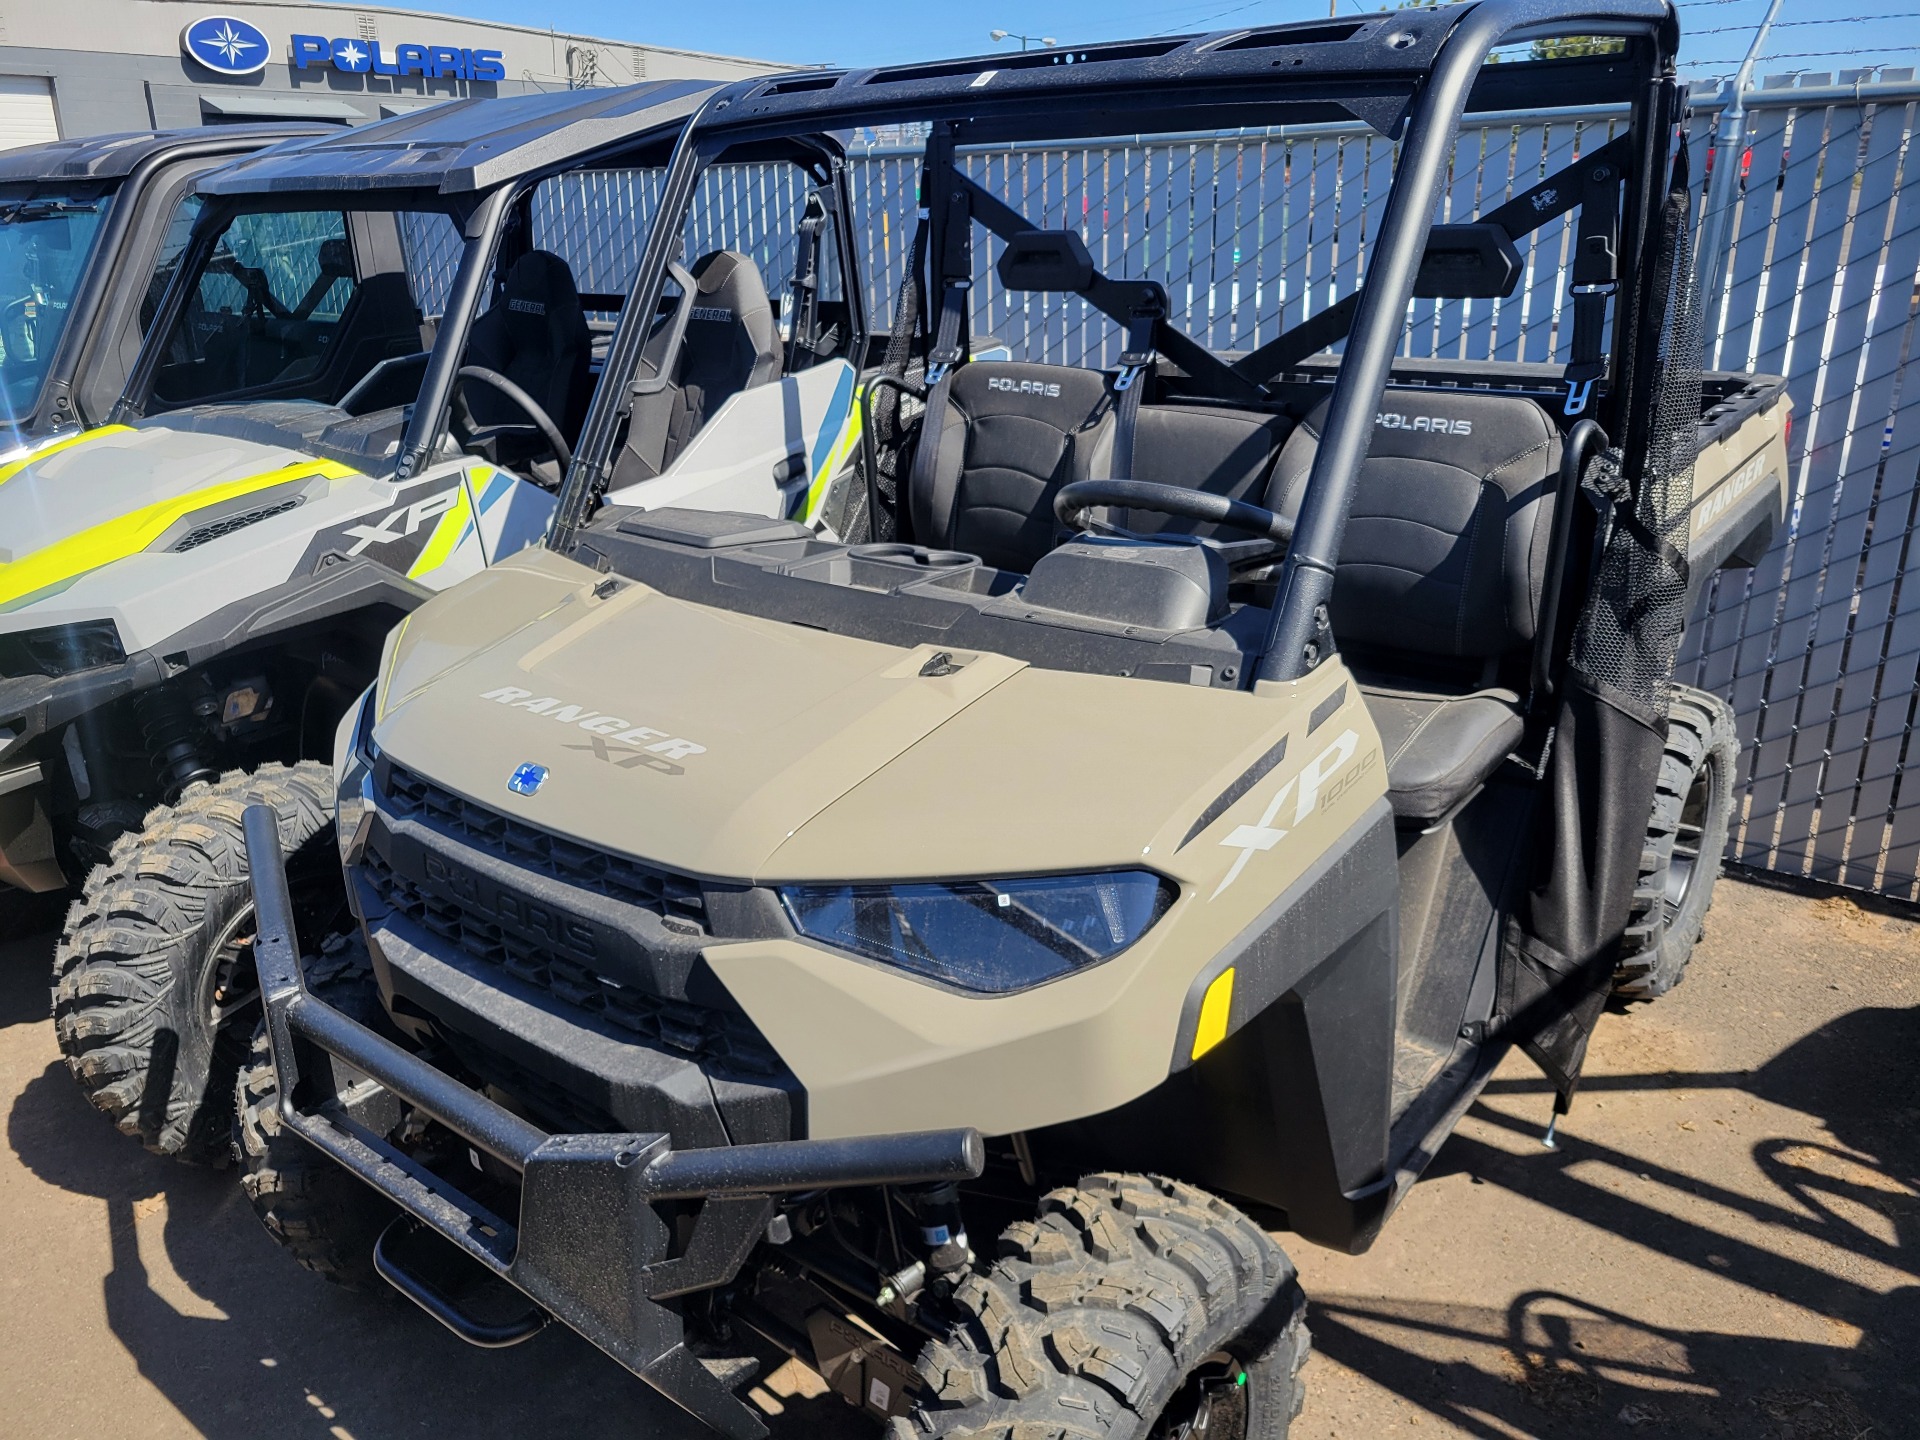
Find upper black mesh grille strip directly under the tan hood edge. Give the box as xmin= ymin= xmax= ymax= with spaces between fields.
xmin=384 ymin=764 xmax=707 ymax=935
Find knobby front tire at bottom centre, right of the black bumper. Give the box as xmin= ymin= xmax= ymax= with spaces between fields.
xmin=893 ymin=1175 xmax=1309 ymax=1440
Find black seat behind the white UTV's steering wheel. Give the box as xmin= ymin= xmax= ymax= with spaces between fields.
xmin=463 ymin=250 xmax=593 ymax=444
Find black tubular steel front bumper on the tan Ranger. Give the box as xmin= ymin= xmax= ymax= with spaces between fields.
xmin=246 ymin=806 xmax=985 ymax=1436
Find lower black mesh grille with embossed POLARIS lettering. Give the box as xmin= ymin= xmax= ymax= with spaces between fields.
xmin=361 ymin=847 xmax=781 ymax=1075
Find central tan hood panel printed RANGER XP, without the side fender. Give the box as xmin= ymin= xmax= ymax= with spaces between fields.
xmin=374 ymin=551 xmax=1023 ymax=879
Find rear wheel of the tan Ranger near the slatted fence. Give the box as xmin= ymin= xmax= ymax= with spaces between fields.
xmin=1613 ymin=685 xmax=1740 ymax=1000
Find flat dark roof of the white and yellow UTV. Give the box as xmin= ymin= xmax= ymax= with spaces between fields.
xmin=200 ymin=81 xmax=720 ymax=196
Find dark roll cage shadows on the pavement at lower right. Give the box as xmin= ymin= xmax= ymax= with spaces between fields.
xmin=1313 ymin=1008 xmax=1920 ymax=1440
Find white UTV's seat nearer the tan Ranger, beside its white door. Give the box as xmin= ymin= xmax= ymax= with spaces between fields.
xmin=614 ymin=250 xmax=781 ymax=484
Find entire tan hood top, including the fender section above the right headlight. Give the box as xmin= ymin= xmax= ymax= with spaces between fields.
xmin=374 ymin=551 xmax=1332 ymax=883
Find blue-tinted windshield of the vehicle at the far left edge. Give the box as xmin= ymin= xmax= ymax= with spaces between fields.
xmin=0 ymin=196 xmax=108 ymax=424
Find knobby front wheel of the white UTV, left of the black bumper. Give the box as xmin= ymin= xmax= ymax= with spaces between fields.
xmin=54 ymin=762 xmax=346 ymax=1164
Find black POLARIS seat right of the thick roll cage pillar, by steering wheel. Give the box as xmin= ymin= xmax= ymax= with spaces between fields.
xmin=1269 ymin=390 xmax=1561 ymax=824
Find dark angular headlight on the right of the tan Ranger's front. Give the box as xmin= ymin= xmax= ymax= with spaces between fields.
xmin=780 ymin=870 xmax=1173 ymax=995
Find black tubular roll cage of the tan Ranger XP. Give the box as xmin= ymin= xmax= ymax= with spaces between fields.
xmin=547 ymin=0 xmax=1686 ymax=695
